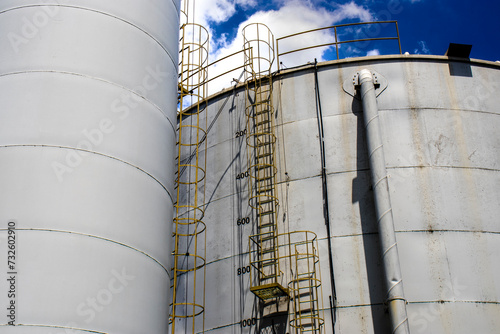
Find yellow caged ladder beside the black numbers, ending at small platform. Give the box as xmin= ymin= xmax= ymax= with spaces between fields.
xmin=243 ymin=23 xmax=288 ymax=300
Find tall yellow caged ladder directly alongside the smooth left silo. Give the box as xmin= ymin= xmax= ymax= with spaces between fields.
xmin=170 ymin=5 xmax=209 ymax=334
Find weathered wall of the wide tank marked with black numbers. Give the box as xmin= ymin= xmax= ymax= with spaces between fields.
xmin=197 ymin=56 xmax=500 ymax=334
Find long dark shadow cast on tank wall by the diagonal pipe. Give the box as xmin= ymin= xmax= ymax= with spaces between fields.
xmin=351 ymin=98 xmax=391 ymax=334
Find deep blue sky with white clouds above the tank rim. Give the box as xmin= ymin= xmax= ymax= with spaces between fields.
xmin=187 ymin=0 xmax=500 ymax=91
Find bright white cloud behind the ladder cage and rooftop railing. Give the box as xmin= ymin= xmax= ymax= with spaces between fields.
xmin=202 ymin=0 xmax=373 ymax=93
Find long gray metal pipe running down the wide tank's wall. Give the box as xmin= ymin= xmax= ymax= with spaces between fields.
xmin=359 ymin=69 xmax=410 ymax=334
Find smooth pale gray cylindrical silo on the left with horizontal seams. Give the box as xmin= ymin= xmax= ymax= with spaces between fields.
xmin=0 ymin=0 xmax=180 ymax=334
